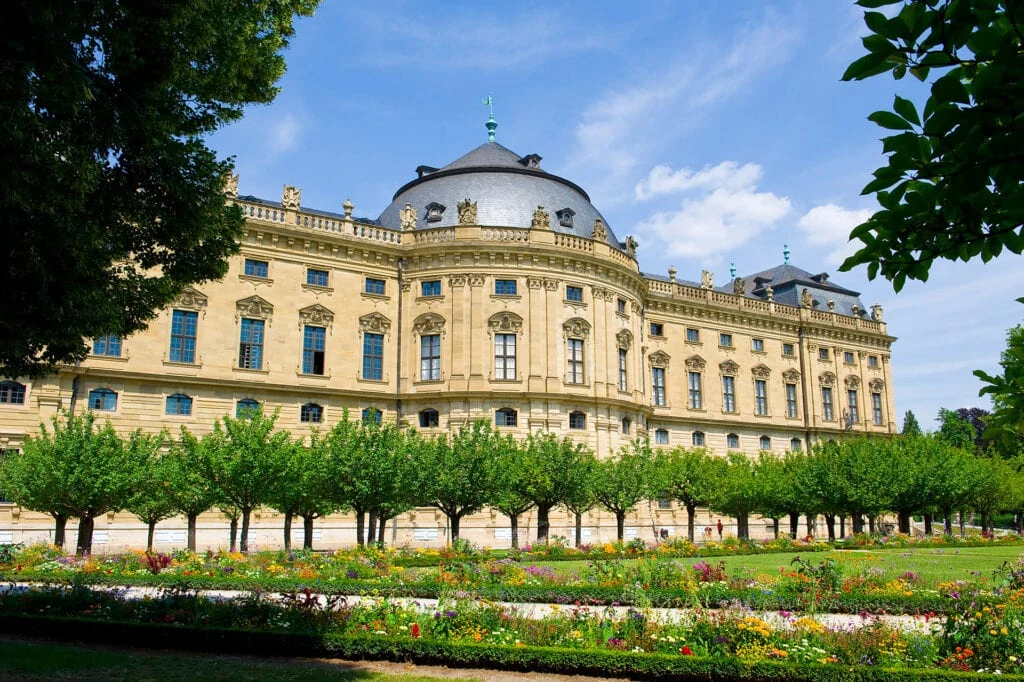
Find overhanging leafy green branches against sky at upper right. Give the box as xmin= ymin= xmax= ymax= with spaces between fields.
xmin=840 ymin=0 xmax=1024 ymax=291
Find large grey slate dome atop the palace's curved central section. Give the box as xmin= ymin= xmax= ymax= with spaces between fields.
xmin=377 ymin=141 xmax=625 ymax=251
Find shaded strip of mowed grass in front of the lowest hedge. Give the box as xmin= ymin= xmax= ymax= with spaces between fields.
xmin=0 ymin=640 xmax=475 ymax=682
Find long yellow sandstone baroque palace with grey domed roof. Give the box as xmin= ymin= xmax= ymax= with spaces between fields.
xmin=0 ymin=131 xmax=896 ymax=552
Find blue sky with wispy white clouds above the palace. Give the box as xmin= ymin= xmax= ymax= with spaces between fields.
xmin=212 ymin=0 xmax=1024 ymax=428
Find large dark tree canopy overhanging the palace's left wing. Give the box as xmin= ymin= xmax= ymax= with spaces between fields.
xmin=0 ymin=0 xmax=317 ymax=376
